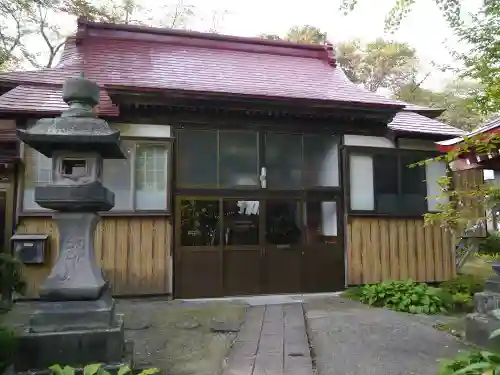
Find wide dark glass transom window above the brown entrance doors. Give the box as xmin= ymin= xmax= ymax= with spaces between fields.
xmin=177 ymin=129 xmax=339 ymax=190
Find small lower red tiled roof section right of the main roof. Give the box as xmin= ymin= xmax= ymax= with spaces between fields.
xmin=388 ymin=111 xmax=464 ymax=136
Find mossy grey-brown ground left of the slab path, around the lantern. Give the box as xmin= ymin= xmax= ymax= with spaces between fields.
xmin=4 ymin=299 xmax=246 ymax=375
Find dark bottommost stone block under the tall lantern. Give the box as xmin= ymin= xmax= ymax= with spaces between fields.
xmin=14 ymin=321 xmax=126 ymax=372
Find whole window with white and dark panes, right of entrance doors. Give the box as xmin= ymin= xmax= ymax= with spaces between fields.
xmin=348 ymin=150 xmax=446 ymax=216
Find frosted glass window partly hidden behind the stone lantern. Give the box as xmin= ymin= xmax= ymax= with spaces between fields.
xmin=23 ymin=141 xmax=171 ymax=211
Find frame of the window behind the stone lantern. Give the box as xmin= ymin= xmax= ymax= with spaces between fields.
xmin=19 ymin=139 xmax=174 ymax=216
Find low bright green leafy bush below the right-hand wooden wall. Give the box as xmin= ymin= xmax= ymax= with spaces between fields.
xmin=348 ymin=280 xmax=453 ymax=314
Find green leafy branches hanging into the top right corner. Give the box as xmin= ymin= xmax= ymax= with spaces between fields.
xmin=341 ymin=0 xmax=500 ymax=113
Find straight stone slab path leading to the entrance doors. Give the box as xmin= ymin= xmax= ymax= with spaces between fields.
xmin=223 ymin=304 xmax=313 ymax=375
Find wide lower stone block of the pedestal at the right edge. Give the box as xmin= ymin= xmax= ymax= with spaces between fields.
xmin=465 ymin=313 xmax=500 ymax=350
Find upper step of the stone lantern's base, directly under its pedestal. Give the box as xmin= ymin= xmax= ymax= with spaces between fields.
xmin=29 ymin=295 xmax=116 ymax=332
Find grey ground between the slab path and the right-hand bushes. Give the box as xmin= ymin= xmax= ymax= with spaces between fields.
xmin=304 ymin=297 xmax=470 ymax=375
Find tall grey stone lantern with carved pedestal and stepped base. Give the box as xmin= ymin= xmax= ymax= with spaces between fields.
xmin=14 ymin=75 xmax=133 ymax=372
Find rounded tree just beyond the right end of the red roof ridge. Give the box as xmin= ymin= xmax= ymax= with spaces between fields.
xmin=337 ymin=38 xmax=418 ymax=92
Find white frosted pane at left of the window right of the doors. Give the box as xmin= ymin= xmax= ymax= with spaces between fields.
xmin=349 ymin=155 xmax=375 ymax=211
